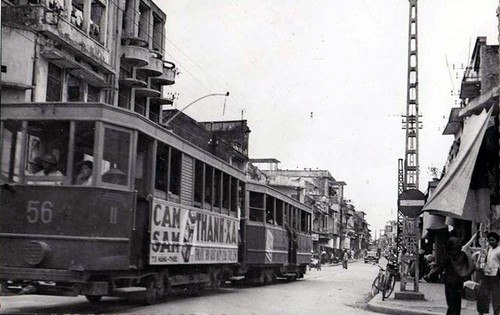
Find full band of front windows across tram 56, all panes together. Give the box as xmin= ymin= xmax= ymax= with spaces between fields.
xmin=1 ymin=120 xmax=132 ymax=186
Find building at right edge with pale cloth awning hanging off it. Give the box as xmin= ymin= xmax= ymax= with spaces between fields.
xmin=424 ymin=37 xmax=500 ymax=239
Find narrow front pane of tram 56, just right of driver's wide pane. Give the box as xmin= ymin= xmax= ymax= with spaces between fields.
xmin=71 ymin=122 xmax=95 ymax=186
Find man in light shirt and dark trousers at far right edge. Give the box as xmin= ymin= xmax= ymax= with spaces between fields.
xmin=476 ymin=232 xmax=500 ymax=315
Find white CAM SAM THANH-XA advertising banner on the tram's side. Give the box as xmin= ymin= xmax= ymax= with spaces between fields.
xmin=149 ymin=199 xmax=238 ymax=265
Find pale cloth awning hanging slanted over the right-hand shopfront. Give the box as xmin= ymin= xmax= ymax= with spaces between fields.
xmin=422 ymin=109 xmax=493 ymax=222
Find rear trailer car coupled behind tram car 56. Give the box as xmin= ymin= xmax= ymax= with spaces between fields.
xmin=241 ymin=181 xmax=312 ymax=284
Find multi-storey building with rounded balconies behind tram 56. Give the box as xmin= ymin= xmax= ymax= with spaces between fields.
xmin=1 ymin=0 xmax=176 ymax=122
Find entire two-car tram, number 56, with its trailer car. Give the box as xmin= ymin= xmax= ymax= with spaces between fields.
xmin=0 ymin=103 xmax=312 ymax=304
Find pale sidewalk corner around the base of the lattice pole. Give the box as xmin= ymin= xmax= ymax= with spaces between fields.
xmin=368 ymin=282 xmax=477 ymax=315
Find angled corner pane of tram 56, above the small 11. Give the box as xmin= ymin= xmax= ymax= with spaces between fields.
xmin=101 ymin=128 xmax=131 ymax=186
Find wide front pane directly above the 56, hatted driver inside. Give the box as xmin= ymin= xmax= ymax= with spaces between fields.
xmin=25 ymin=120 xmax=69 ymax=185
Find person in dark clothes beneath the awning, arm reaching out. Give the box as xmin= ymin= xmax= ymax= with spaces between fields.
xmin=424 ymin=235 xmax=475 ymax=315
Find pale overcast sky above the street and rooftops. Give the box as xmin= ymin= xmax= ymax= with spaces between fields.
xmin=156 ymin=0 xmax=498 ymax=235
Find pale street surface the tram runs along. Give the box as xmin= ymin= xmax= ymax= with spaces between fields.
xmin=0 ymin=261 xmax=385 ymax=315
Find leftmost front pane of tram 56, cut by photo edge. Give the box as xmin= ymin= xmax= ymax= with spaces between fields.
xmin=1 ymin=120 xmax=22 ymax=182
